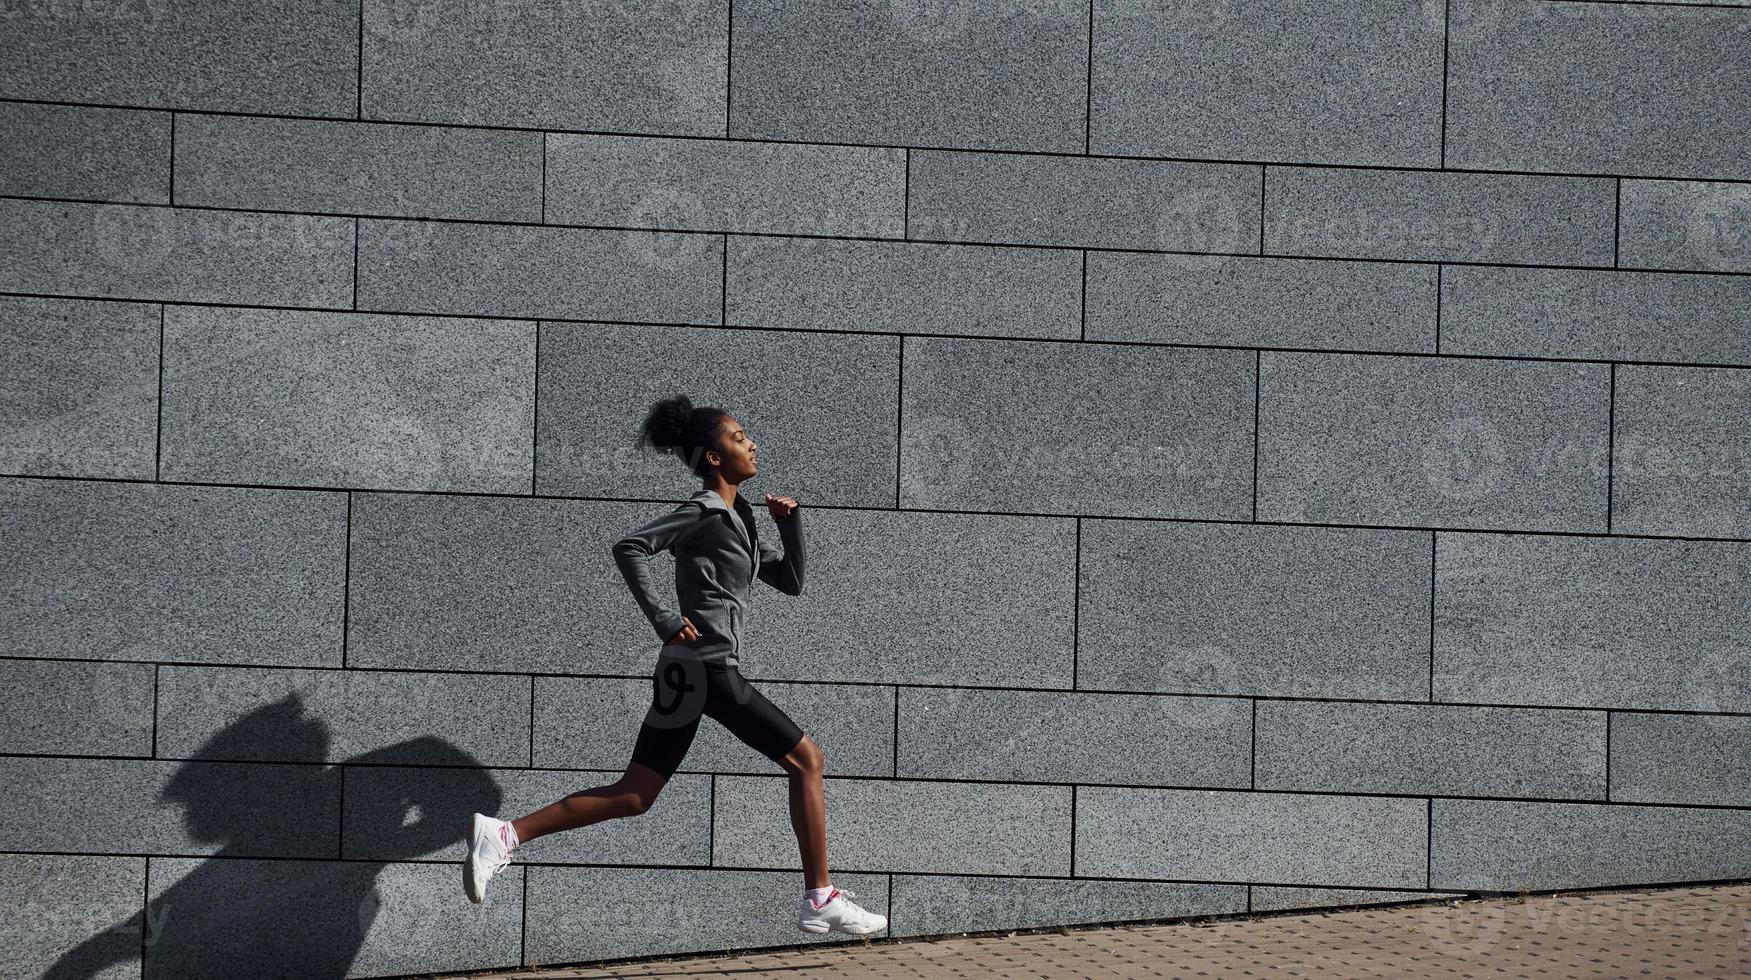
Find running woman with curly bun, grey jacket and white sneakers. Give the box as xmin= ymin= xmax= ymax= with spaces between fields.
xmin=462 ymin=396 xmax=888 ymax=936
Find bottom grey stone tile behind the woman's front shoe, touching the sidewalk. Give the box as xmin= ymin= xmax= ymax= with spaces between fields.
xmin=521 ymin=865 xmax=891 ymax=964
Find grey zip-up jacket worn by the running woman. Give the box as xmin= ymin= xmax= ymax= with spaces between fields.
xmin=613 ymin=488 xmax=802 ymax=667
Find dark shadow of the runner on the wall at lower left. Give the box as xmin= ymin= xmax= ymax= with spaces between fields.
xmin=44 ymin=693 xmax=501 ymax=980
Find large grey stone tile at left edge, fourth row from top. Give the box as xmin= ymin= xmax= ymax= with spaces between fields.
xmin=0 ymin=296 xmax=161 ymax=480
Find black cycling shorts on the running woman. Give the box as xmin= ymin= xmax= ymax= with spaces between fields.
xmin=632 ymin=646 xmax=802 ymax=779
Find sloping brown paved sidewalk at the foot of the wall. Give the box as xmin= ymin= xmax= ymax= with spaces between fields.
xmin=430 ymin=884 xmax=1751 ymax=980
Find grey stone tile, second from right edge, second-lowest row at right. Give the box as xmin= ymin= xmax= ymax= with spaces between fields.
xmin=1254 ymin=700 xmax=1606 ymax=800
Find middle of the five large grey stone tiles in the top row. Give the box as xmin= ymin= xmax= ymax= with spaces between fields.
xmin=730 ymin=0 xmax=1089 ymax=152
